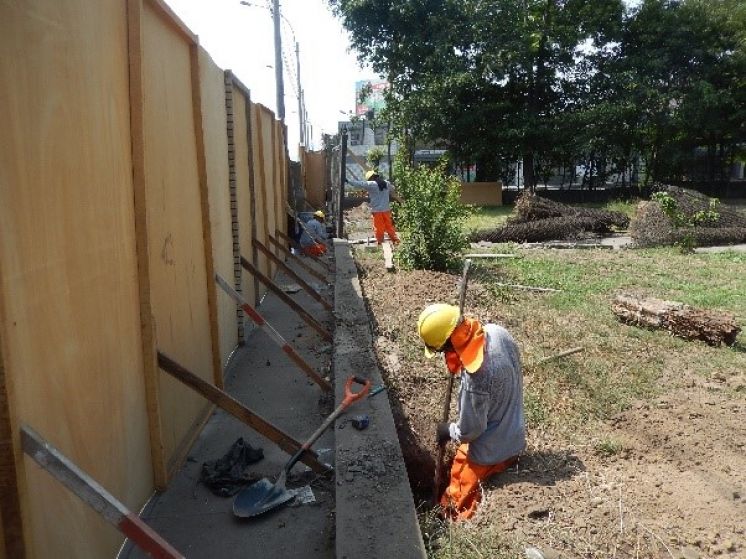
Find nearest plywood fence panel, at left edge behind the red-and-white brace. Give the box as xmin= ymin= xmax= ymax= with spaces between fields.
xmin=0 ymin=0 xmax=153 ymax=559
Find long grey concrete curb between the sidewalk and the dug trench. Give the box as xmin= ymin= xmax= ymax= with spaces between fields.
xmin=333 ymin=239 xmax=425 ymax=559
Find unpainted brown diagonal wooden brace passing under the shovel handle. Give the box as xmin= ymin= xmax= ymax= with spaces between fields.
xmin=158 ymin=351 xmax=331 ymax=474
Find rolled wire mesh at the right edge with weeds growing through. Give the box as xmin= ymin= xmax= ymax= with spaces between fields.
xmin=629 ymin=186 xmax=746 ymax=247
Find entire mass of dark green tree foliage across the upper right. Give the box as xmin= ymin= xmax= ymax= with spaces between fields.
xmin=329 ymin=0 xmax=746 ymax=186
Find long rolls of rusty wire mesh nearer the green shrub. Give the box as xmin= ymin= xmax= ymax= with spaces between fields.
xmin=470 ymin=193 xmax=629 ymax=243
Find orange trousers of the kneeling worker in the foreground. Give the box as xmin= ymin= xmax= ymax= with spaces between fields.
xmin=440 ymin=443 xmax=518 ymax=520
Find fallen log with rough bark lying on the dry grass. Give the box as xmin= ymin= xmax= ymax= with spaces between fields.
xmin=611 ymin=294 xmax=741 ymax=346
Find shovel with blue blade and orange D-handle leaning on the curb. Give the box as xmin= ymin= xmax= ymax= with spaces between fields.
xmin=233 ymin=377 xmax=370 ymax=518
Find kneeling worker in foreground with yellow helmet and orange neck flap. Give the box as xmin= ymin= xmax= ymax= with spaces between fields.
xmin=417 ymin=304 xmax=526 ymax=520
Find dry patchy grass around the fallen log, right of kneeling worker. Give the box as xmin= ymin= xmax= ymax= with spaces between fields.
xmin=472 ymin=248 xmax=746 ymax=432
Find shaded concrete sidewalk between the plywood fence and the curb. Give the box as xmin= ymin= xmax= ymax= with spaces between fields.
xmin=119 ymin=267 xmax=335 ymax=559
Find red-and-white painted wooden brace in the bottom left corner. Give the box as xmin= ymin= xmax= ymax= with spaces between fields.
xmin=21 ymin=426 xmax=184 ymax=559
